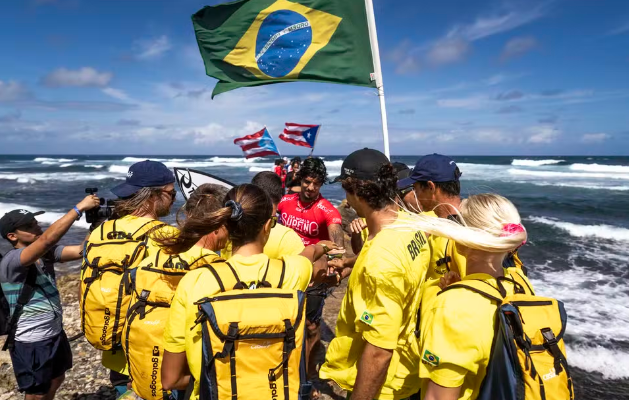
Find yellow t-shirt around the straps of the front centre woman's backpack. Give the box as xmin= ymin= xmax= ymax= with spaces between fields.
xmin=164 ymin=254 xmax=312 ymax=399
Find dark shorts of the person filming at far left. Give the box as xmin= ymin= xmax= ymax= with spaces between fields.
xmin=10 ymin=331 xmax=72 ymax=395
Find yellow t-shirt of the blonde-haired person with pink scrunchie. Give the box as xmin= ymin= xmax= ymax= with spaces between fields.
xmin=419 ymin=269 xmax=528 ymax=400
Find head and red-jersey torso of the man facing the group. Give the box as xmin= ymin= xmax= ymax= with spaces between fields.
xmin=277 ymin=158 xmax=343 ymax=247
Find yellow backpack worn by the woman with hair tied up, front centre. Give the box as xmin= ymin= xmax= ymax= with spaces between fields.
xmin=195 ymin=260 xmax=312 ymax=400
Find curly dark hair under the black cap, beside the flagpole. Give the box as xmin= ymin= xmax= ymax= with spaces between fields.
xmin=342 ymin=164 xmax=397 ymax=211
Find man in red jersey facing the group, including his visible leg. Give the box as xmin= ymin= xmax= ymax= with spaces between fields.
xmin=277 ymin=158 xmax=345 ymax=390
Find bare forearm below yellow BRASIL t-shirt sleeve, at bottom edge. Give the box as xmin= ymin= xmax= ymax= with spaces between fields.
xmin=352 ymin=342 xmax=393 ymax=400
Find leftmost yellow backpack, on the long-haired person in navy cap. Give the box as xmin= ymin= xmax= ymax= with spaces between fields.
xmin=79 ymin=219 xmax=165 ymax=351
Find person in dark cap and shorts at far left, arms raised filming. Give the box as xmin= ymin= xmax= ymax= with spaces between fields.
xmin=0 ymin=195 xmax=99 ymax=400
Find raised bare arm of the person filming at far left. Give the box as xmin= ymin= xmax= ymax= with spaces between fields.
xmin=20 ymin=195 xmax=100 ymax=265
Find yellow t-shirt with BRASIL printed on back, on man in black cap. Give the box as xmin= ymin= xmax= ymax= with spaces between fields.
xmin=319 ymin=214 xmax=430 ymax=400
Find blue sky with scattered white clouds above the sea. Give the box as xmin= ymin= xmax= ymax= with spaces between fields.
xmin=0 ymin=0 xmax=629 ymax=155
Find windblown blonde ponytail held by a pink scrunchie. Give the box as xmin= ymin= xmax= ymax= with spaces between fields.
xmin=392 ymin=193 xmax=527 ymax=253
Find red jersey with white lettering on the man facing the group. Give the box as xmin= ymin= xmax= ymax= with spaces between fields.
xmin=277 ymin=193 xmax=343 ymax=246
